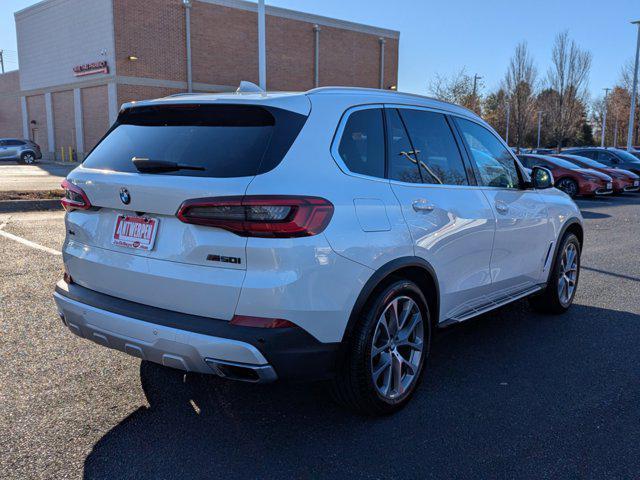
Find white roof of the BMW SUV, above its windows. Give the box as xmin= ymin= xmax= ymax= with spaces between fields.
xmin=122 ymin=87 xmax=486 ymax=124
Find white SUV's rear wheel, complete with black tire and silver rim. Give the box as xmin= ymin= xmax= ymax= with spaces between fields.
xmin=332 ymin=280 xmax=431 ymax=416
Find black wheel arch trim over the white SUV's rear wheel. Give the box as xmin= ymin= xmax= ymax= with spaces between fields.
xmin=341 ymin=256 xmax=440 ymax=345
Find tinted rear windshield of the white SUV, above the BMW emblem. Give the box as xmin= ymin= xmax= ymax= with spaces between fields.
xmin=83 ymin=104 xmax=307 ymax=178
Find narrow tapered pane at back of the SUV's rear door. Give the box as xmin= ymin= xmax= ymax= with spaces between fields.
xmin=385 ymin=109 xmax=422 ymax=183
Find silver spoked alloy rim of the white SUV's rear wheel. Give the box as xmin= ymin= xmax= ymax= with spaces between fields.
xmin=371 ymin=296 xmax=424 ymax=400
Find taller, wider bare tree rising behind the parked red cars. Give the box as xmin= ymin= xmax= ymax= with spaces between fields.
xmin=547 ymin=32 xmax=591 ymax=151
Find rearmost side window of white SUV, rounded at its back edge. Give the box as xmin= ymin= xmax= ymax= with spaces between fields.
xmin=338 ymin=108 xmax=384 ymax=178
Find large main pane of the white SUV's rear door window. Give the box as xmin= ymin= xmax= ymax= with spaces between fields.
xmin=399 ymin=108 xmax=469 ymax=185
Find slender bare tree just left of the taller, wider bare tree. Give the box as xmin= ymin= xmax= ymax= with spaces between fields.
xmin=503 ymin=42 xmax=537 ymax=151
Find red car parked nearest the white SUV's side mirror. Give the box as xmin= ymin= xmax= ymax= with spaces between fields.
xmin=518 ymin=155 xmax=613 ymax=197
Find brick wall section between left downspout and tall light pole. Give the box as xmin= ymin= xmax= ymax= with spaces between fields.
xmin=191 ymin=2 xmax=258 ymax=85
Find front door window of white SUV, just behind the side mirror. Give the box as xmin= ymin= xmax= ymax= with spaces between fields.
xmin=456 ymin=118 xmax=518 ymax=188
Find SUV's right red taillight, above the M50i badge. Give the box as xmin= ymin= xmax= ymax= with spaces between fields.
xmin=177 ymin=195 xmax=333 ymax=238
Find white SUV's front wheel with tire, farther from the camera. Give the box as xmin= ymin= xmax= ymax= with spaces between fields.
xmin=529 ymin=233 xmax=581 ymax=315
